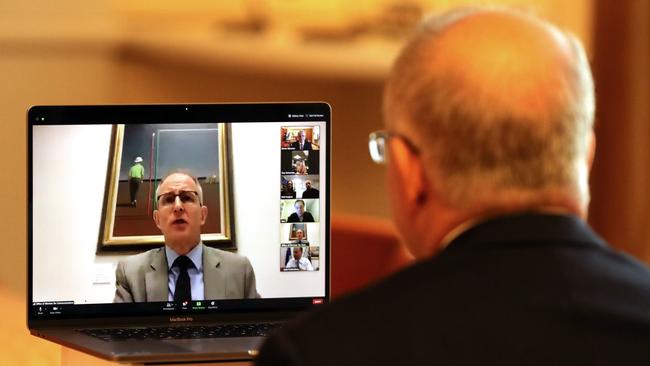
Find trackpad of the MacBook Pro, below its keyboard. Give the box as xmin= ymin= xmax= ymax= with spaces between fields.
xmin=163 ymin=337 xmax=264 ymax=354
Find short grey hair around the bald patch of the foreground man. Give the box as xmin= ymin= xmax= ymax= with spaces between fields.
xmin=384 ymin=7 xmax=594 ymax=207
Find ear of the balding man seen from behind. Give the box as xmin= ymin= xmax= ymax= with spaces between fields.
xmin=389 ymin=138 xmax=429 ymax=207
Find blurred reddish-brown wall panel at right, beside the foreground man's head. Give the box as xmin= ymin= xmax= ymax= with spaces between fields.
xmin=590 ymin=0 xmax=650 ymax=263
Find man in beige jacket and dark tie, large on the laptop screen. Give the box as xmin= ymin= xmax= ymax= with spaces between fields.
xmin=113 ymin=171 xmax=259 ymax=302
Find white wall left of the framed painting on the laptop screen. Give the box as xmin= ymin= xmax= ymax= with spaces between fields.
xmin=32 ymin=125 xmax=118 ymax=303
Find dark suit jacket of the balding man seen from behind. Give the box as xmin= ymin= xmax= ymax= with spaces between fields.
xmin=258 ymin=214 xmax=650 ymax=366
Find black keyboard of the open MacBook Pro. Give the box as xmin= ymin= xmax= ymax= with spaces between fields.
xmin=78 ymin=323 xmax=282 ymax=342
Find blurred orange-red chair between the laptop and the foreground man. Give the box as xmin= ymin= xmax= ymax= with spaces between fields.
xmin=330 ymin=215 xmax=413 ymax=298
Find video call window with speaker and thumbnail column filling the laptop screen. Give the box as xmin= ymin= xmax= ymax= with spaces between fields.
xmin=31 ymin=121 xmax=328 ymax=316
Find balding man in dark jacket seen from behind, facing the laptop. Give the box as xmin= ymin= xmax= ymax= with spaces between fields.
xmin=258 ymin=8 xmax=650 ymax=366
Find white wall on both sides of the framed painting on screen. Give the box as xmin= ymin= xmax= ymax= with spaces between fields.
xmin=32 ymin=123 xmax=327 ymax=303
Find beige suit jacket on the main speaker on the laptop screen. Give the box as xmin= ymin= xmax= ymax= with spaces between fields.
xmin=113 ymin=244 xmax=259 ymax=302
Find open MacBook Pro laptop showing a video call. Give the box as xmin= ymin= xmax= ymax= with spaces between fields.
xmin=27 ymin=102 xmax=331 ymax=363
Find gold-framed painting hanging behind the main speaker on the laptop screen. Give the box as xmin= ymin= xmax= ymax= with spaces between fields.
xmin=97 ymin=123 xmax=235 ymax=253
